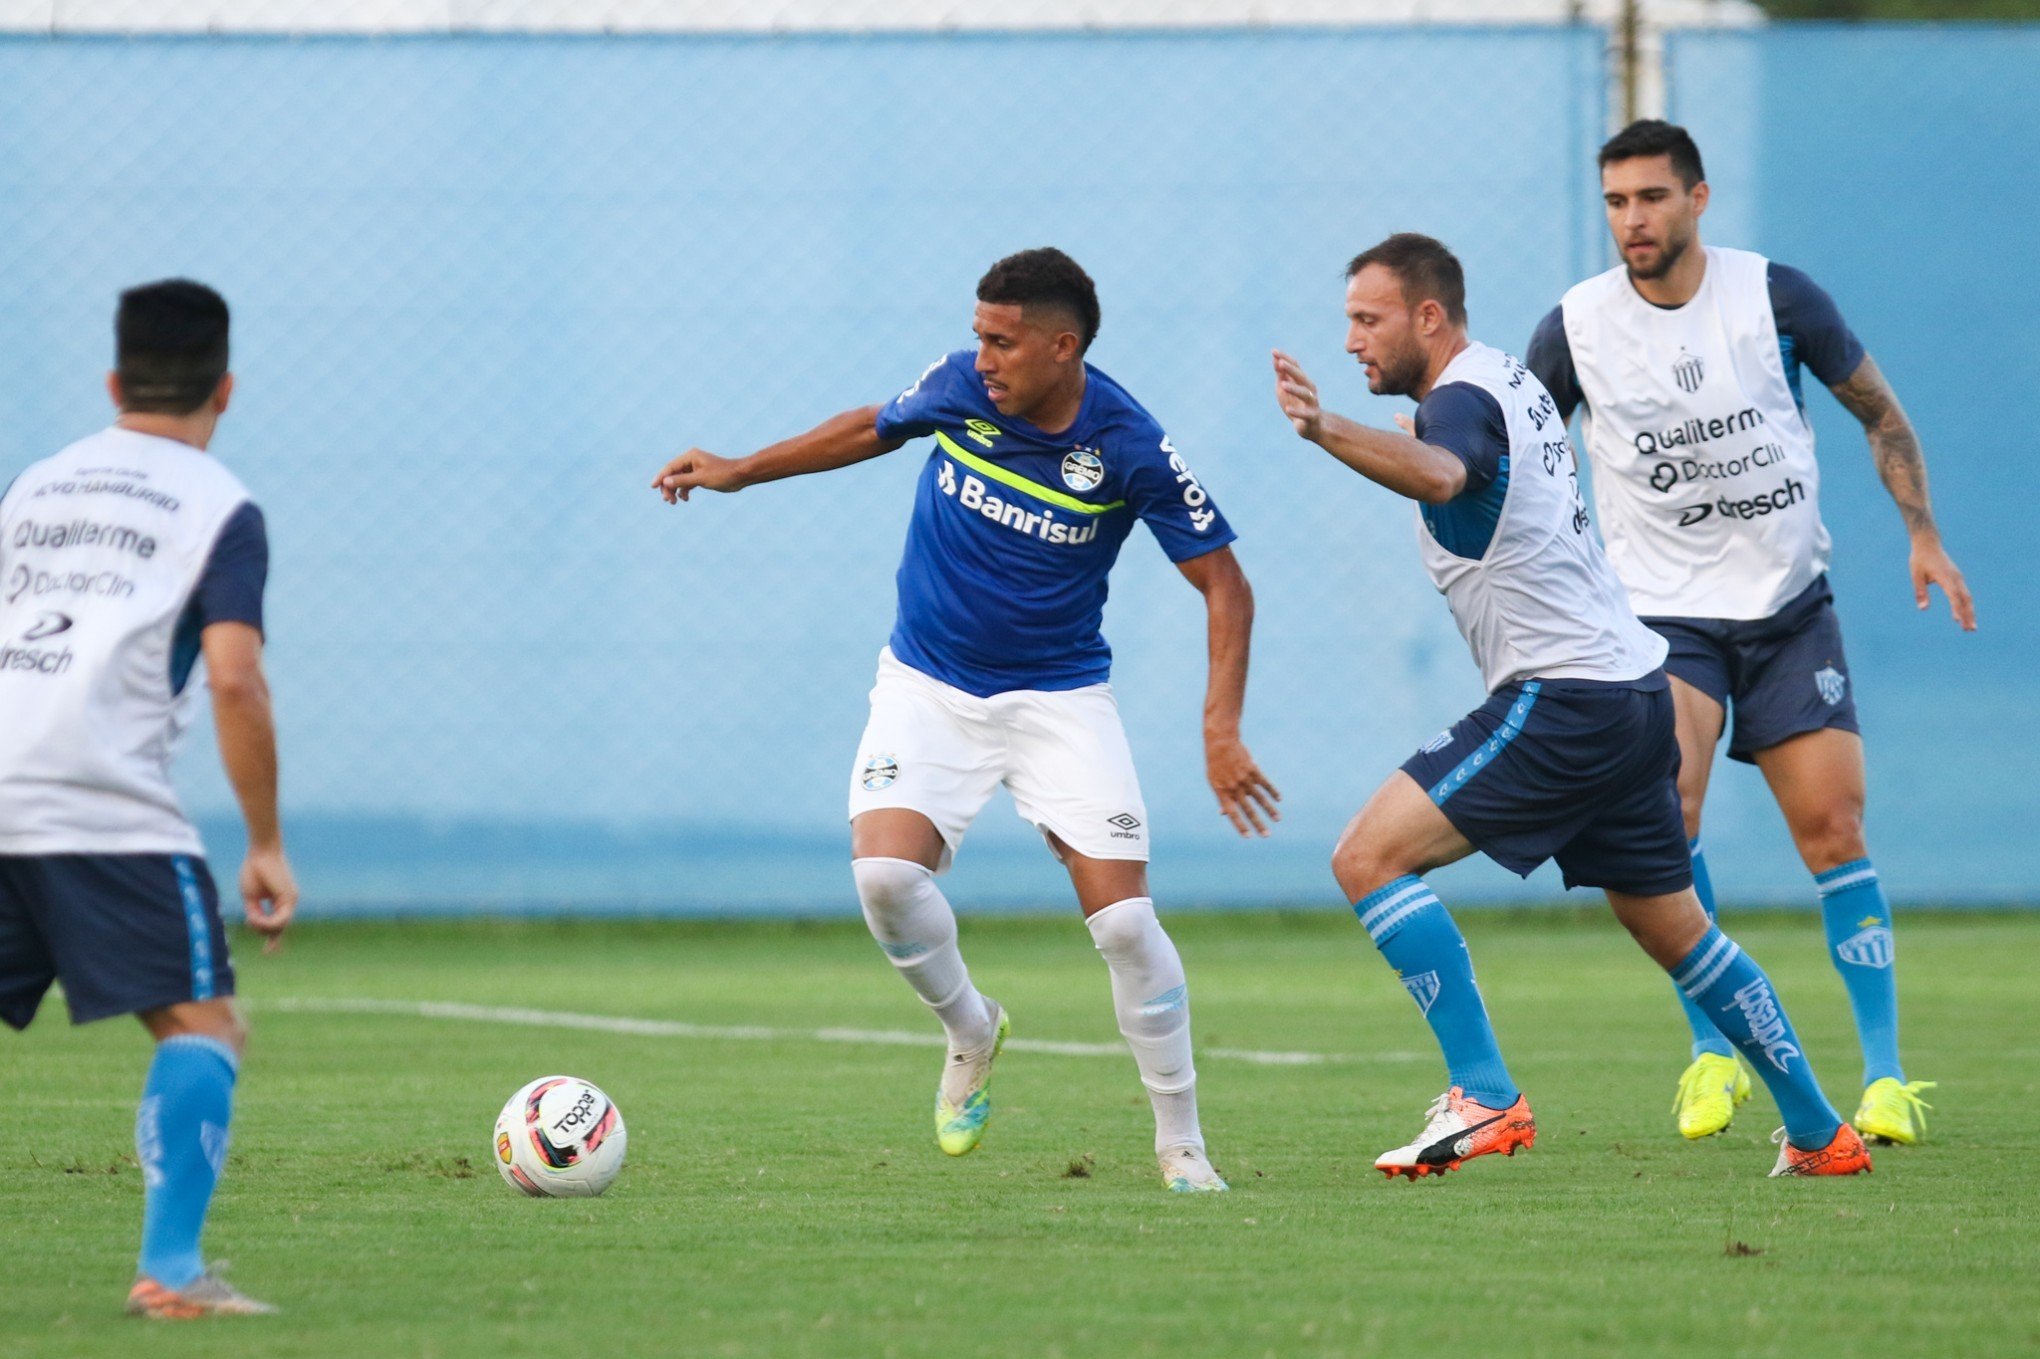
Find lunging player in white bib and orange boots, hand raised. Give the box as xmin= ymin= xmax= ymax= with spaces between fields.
xmin=1275 ymin=233 xmax=1871 ymax=1179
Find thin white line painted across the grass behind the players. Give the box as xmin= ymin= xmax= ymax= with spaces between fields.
xmin=259 ymin=996 xmax=1436 ymax=1067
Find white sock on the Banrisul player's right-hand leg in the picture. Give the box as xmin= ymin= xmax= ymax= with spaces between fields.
xmin=1085 ymin=896 xmax=1204 ymax=1155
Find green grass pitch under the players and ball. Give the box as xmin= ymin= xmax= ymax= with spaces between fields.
xmin=0 ymin=912 xmax=2040 ymax=1359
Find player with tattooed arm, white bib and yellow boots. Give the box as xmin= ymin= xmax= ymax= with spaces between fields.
xmin=1528 ymin=120 xmax=1977 ymax=1143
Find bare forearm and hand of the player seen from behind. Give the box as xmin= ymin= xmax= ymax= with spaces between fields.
xmin=198 ymin=622 xmax=298 ymax=953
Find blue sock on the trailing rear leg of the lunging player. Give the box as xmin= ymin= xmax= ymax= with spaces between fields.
xmin=1671 ymin=926 xmax=1842 ymax=1151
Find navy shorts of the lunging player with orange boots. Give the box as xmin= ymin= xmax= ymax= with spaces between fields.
xmin=1404 ymin=671 xmax=1693 ymax=896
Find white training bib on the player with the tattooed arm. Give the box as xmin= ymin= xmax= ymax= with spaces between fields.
xmin=1561 ymin=247 xmax=1828 ymax=618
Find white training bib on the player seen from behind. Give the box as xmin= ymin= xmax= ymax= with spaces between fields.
xmin=0 ymin=426 xmax=249 ymax=855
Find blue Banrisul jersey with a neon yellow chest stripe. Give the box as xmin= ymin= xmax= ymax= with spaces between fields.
xmin=877 ymin=349 xmax=1236 ymax=698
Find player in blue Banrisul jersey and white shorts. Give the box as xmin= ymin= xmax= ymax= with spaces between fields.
xmin=653 ymin=249 xmax=1277 ymax=1192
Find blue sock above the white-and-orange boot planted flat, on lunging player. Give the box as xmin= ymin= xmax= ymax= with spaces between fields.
xmin=1353 ymin=873 xmax=1522 ymax=1108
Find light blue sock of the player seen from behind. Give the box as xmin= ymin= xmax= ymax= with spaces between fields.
xmin=135 ymin=1033 xmax=239 ymax=1288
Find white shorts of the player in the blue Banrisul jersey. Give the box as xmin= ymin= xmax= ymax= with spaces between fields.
xmin=851 ymin=647 xmax=1149 ymax=869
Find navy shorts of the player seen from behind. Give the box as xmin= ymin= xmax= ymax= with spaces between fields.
xmin=0 ymin=855 xmax=235 ymax=1028
